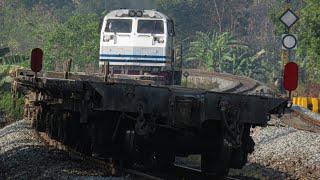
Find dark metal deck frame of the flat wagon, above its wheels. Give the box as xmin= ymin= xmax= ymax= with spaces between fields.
xmin=16 ymin=69 xmax=287 ymax=128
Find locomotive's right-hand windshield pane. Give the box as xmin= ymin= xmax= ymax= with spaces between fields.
xmin=138 ymin=20 xmax=164 ymax=34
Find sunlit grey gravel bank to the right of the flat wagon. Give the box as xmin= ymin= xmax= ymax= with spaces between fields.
xmin=243 ymin=126 xmax=320 ymax=179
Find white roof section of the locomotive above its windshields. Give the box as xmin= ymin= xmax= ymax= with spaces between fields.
xmin=105 ymin=9 xmax=171 ymax=19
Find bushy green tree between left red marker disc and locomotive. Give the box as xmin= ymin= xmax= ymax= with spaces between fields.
xmin=45 ymin=13 xmax=100 ymax=70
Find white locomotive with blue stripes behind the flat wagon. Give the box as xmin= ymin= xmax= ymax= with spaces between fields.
xmin=99 ymin=9 xmax=179 ymax=83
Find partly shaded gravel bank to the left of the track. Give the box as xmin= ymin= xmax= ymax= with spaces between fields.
xmin=0 ymin=120 xmax=119 ymax=179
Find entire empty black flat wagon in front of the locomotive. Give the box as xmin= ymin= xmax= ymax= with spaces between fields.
xmin=12 ymin=68 xmax=288 ymax=175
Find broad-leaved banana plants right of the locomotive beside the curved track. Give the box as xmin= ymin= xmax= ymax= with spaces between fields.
xmin=187 ymin=31 xmax=279 ymax=81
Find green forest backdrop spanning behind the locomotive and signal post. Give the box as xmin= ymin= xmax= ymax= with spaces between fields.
xmin=0 ymin=0 xmax=320 ymax=83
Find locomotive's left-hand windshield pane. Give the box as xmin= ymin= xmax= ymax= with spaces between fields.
xmin=106 ymin=19 xmax=132 ymax=33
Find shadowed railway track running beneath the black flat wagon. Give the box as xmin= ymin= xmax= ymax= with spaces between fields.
xmin=35 ymin=131 xmax=236 ymax=180
